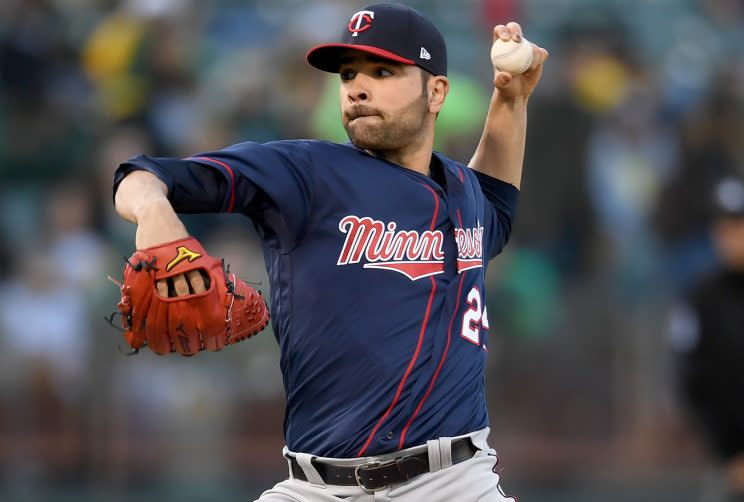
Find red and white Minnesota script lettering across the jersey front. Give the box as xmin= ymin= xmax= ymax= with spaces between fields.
xmin=336 ymin=215 xmax=483 ymax=281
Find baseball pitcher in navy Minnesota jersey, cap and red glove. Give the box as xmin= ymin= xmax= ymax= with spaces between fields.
xmin=114 ymin=4 xmax=548 ymax=502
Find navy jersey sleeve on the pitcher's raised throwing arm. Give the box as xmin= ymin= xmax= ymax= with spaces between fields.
xmin=472 ymin=170 xmax=519 ymax=260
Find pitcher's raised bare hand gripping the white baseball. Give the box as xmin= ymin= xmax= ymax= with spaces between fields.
xmin=491 ymin=21 xmax=549 ymax=98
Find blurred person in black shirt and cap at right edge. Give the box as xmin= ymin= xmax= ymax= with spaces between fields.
xmin=669 ymin=178 xmax=744 ymax=502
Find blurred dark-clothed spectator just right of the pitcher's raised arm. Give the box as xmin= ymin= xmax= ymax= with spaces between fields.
xmin=513 ymin=21 xmax=624 ymax=283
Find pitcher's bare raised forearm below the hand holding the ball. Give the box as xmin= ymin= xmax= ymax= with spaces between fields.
xmin=468 ymin=89 xmax=527 ymax=188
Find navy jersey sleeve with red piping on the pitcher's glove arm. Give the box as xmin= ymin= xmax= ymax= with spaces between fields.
xmin=114 ymin=141 xmax=314 ymax=250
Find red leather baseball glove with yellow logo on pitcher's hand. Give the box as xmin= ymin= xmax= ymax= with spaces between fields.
xmin=107 ymin=237 xmax=269 ymax=356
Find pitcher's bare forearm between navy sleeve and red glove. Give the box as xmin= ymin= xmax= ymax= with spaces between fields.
xmin=115 ymin=171 xmax=188 ymax=249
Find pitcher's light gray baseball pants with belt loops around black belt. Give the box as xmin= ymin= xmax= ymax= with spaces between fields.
xmin=256 ymin=428 xmax=516 ymax=502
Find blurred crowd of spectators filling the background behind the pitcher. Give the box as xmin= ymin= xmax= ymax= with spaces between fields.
xmin=0 ymin=0 xmax=744 ymax=500
